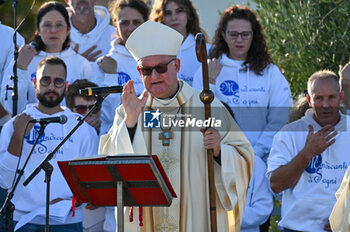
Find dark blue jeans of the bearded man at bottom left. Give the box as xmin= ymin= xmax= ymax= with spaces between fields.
xmin=16 ymin=222 xmax=83 ymax=232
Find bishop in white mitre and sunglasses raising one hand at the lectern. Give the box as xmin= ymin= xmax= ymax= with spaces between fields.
xmin=99 ymin=21 xmax=254 ymax=231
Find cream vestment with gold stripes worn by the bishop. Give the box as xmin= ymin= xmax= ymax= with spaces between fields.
xmin=99 ymin=80 xmax=254 ymax=232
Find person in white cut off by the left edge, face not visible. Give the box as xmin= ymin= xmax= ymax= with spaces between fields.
xmin=0 ymin=22 xmax=24 ymax=127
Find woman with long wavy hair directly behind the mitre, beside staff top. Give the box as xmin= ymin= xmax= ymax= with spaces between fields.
xmin=150 ymin=0 xmax=210 ymax=86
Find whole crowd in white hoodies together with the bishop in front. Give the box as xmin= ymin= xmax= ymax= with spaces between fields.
xmin=0 ymin=0 xmax=350 ymax=232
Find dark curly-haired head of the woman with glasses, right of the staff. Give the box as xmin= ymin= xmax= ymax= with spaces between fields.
xmin=209 ymin=6 xmax=272 ymax=75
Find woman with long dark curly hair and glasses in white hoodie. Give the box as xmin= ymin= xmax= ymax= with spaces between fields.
xmin=193 ymin=6 xmax=291 ymax=231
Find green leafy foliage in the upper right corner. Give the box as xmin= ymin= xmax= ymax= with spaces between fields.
xmin=255 ymin=0 xmax=350 ymax=96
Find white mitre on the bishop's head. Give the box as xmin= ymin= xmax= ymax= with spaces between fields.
xmin=125 ymin=20 xmax=183 ymax=61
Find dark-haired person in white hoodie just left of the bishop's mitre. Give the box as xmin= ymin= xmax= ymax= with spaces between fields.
xmin=100 ymin=0 xmax=150 ymax=133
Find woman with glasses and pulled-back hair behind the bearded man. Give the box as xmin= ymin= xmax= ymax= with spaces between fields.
xmin=1 ymin=1 xmax=92 ymax=115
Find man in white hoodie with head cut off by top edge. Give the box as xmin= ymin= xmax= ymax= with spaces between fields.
xmin=66 ymin=0 xmax=115 ymax=61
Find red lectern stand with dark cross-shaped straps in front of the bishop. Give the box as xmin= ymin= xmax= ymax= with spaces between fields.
xmin=58 ymin=155 xmax=176 ymax=232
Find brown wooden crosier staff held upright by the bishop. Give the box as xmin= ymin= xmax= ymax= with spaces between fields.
xmin=196 ymin=33 xmax=217 ymax=232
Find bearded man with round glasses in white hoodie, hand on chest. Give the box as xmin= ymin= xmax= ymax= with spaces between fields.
xmin=0 ymin=56 xmax=98 ymax=231
